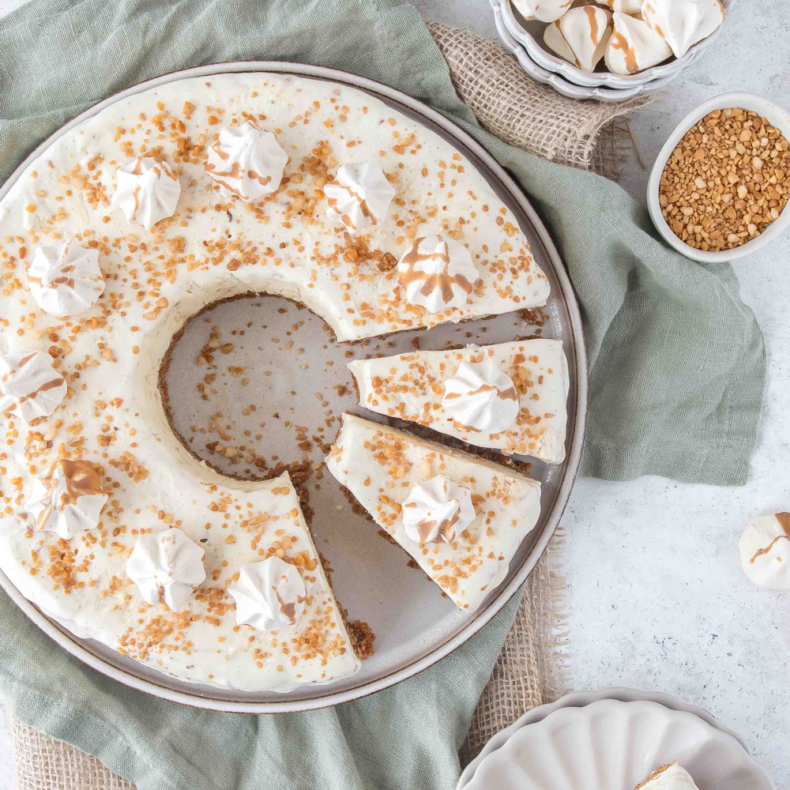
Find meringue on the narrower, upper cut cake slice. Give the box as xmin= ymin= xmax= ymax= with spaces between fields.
xmin=442 ymin=358 xmax=520 ymax=433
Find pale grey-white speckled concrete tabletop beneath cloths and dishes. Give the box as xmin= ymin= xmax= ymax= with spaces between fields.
xmin=0 ymin=0 xmax=790 ymax=790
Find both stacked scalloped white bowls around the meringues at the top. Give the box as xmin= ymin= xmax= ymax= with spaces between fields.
xmin=490 ymin=0 xmax=736 ymax=103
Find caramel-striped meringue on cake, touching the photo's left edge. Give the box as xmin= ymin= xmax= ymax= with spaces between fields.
xmin=0 ymin=351 xmax=68 ymax=425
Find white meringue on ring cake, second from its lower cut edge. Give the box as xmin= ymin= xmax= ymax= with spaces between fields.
xmin=126 ymin=528 xmax=206 ymax=609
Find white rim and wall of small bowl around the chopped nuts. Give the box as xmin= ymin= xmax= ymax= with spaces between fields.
xmin=647 ymin=93 xmax=790 ymax=263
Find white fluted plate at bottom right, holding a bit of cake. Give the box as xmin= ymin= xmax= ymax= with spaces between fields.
xmin=459 ymin=699 xmax=776 ymax=790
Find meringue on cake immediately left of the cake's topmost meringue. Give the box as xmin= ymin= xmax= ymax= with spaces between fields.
xmin=112 ymin=156 xmax=181 ymax=230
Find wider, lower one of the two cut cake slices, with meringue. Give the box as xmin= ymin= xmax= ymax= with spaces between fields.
xmin=326 ymin=414 xmax=540 ymax=612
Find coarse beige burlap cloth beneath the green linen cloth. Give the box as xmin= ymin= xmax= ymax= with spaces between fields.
xmin=7 ymin=22 xmax=638 ymax=790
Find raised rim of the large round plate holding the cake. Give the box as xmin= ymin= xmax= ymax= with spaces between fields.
xmin=0 ymin=60 xmax=587 ymax=713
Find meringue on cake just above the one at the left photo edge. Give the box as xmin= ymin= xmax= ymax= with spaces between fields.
xmin=27 ymin=239 xmax=104 ymax=318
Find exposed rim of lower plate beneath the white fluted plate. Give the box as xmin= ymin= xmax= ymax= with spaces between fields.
xmin=455 ymin=686 xmax=775 ymax=790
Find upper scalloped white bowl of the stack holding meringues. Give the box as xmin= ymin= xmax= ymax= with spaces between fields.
xmin=495 ymin=0 xmax=737 ymax=90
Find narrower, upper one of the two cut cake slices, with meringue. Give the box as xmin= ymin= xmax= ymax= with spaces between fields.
xmin=348 ymin=338 xmax=568 ymax=464
